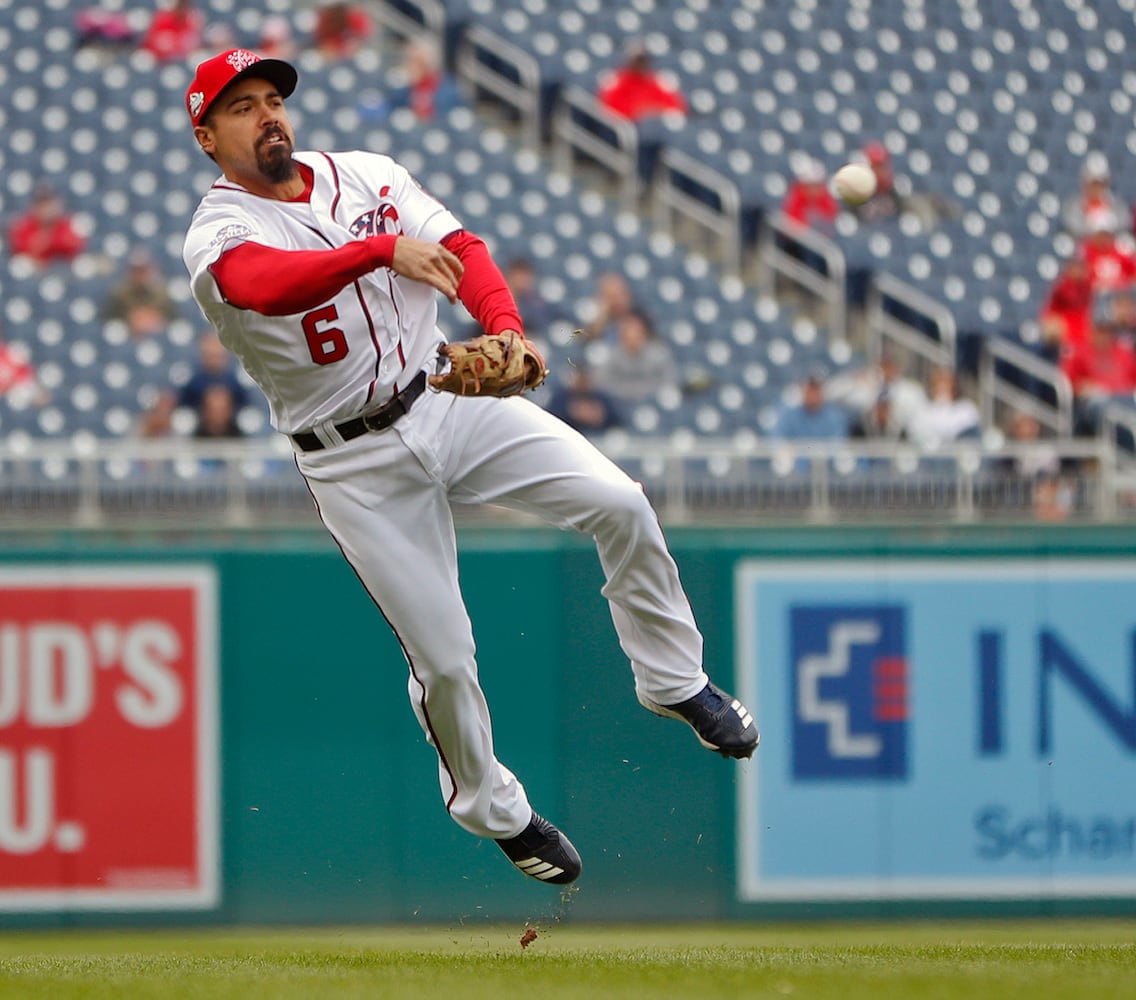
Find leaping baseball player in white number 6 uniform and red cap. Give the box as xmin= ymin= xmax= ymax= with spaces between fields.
xmin=184 ymin=49 xmax=758 ymax=884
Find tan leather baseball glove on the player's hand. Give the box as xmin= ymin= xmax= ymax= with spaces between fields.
xmin=429 ymin=330 xmax=549 ymax=395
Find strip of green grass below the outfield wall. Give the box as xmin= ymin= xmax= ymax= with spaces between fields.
xmin=0 ymin=920 xmax=1136 ymax=1000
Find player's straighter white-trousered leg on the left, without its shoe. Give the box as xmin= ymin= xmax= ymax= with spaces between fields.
xmin=299 ymin=434 xmax=532 ymax=838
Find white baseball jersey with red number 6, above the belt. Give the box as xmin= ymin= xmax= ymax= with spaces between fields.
xmin=183 ymin=152 xmax=461 ymax=434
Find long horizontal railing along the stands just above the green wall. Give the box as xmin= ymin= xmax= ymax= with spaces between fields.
xmin=0 ymin=432 xmax=1117 ymax=531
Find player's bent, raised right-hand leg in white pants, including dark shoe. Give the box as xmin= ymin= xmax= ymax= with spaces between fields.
xmin=446 ymin=399 xmax=758 ymax=756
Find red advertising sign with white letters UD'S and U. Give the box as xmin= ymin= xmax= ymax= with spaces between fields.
xmin=0 ymin=566 xmax=218 ymax=910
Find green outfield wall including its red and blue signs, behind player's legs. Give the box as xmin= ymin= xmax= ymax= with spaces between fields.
xmin=0 ymin=525 xmax=1136 ymax=926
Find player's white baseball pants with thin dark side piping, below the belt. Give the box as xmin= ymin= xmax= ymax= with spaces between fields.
xmin=296 ymin=392 xmax=707 ymax=838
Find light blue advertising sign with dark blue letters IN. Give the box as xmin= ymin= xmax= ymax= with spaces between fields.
xmin=736 ymin=558 xmax=1136 ymax=900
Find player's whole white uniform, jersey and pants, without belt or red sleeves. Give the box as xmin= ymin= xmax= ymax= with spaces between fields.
xmin=185 ymin=142 xmax=708 ymax=838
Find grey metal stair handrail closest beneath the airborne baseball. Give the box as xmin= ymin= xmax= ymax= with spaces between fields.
xmin=758 ymin=213 xmax=847 ymax=338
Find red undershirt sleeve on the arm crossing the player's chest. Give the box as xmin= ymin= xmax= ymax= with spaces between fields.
xmin=209 ymin=234 xmax=399 ymax=316
